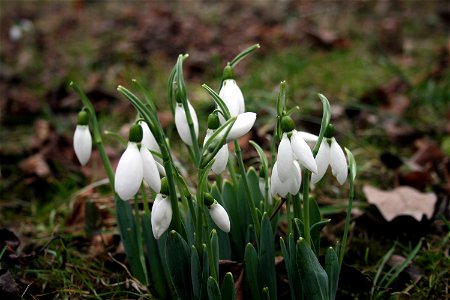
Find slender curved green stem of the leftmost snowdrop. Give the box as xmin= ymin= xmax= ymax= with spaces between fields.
xmin=70 ymin=81 xmax=114 ymax=186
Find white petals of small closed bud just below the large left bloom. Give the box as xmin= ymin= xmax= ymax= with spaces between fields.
xmin=151 ymin=194 xmax=172 ymax=240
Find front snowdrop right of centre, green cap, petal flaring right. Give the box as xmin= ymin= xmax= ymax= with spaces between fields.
xmin=277 ymin=116 xmax=317 ymax=182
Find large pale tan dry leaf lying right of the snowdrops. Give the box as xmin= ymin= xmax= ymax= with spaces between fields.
xmin=363 ymin=185 xmax=437 ymax=222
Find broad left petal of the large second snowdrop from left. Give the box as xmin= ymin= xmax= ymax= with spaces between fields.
xmin=114 ymin=142 xmax=144 ymax=200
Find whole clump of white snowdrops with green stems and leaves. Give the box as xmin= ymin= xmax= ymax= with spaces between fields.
xmin=71 ymin=45 xmax=356 ymax=299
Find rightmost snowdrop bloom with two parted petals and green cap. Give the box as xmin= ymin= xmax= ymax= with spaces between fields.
xmin=311 ymin=124 xmax=348 ymax=185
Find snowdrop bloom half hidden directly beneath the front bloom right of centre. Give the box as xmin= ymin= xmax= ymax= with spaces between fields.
xmin=270 ymin=161 xmax=302 ymax=198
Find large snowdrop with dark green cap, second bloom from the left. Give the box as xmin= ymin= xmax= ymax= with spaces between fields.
xmin=114 ymin=124 xmax=161 ymax=200
